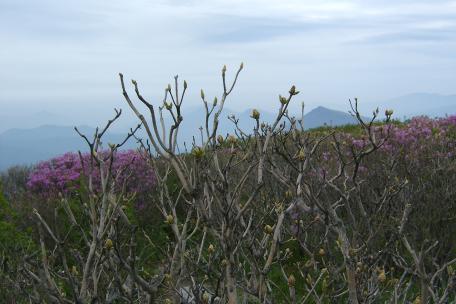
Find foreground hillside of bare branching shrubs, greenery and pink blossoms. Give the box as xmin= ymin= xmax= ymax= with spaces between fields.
xmin=0 ymin=65 xmax=456 ymax=304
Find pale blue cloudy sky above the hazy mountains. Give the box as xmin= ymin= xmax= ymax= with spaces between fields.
xmin=0 ymin=0 xmax=456 ymax=125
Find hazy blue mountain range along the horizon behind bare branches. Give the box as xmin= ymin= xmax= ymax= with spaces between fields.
xmin=0 ymin=93 xmax=456 ymax=171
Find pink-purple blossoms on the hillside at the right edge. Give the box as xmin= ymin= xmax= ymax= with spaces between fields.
xmin=310 ymin=115 xmax=456 ymax=179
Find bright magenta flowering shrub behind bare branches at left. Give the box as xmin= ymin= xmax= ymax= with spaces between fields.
xmin=27 ymin=150 xmax=155 ymax=202
